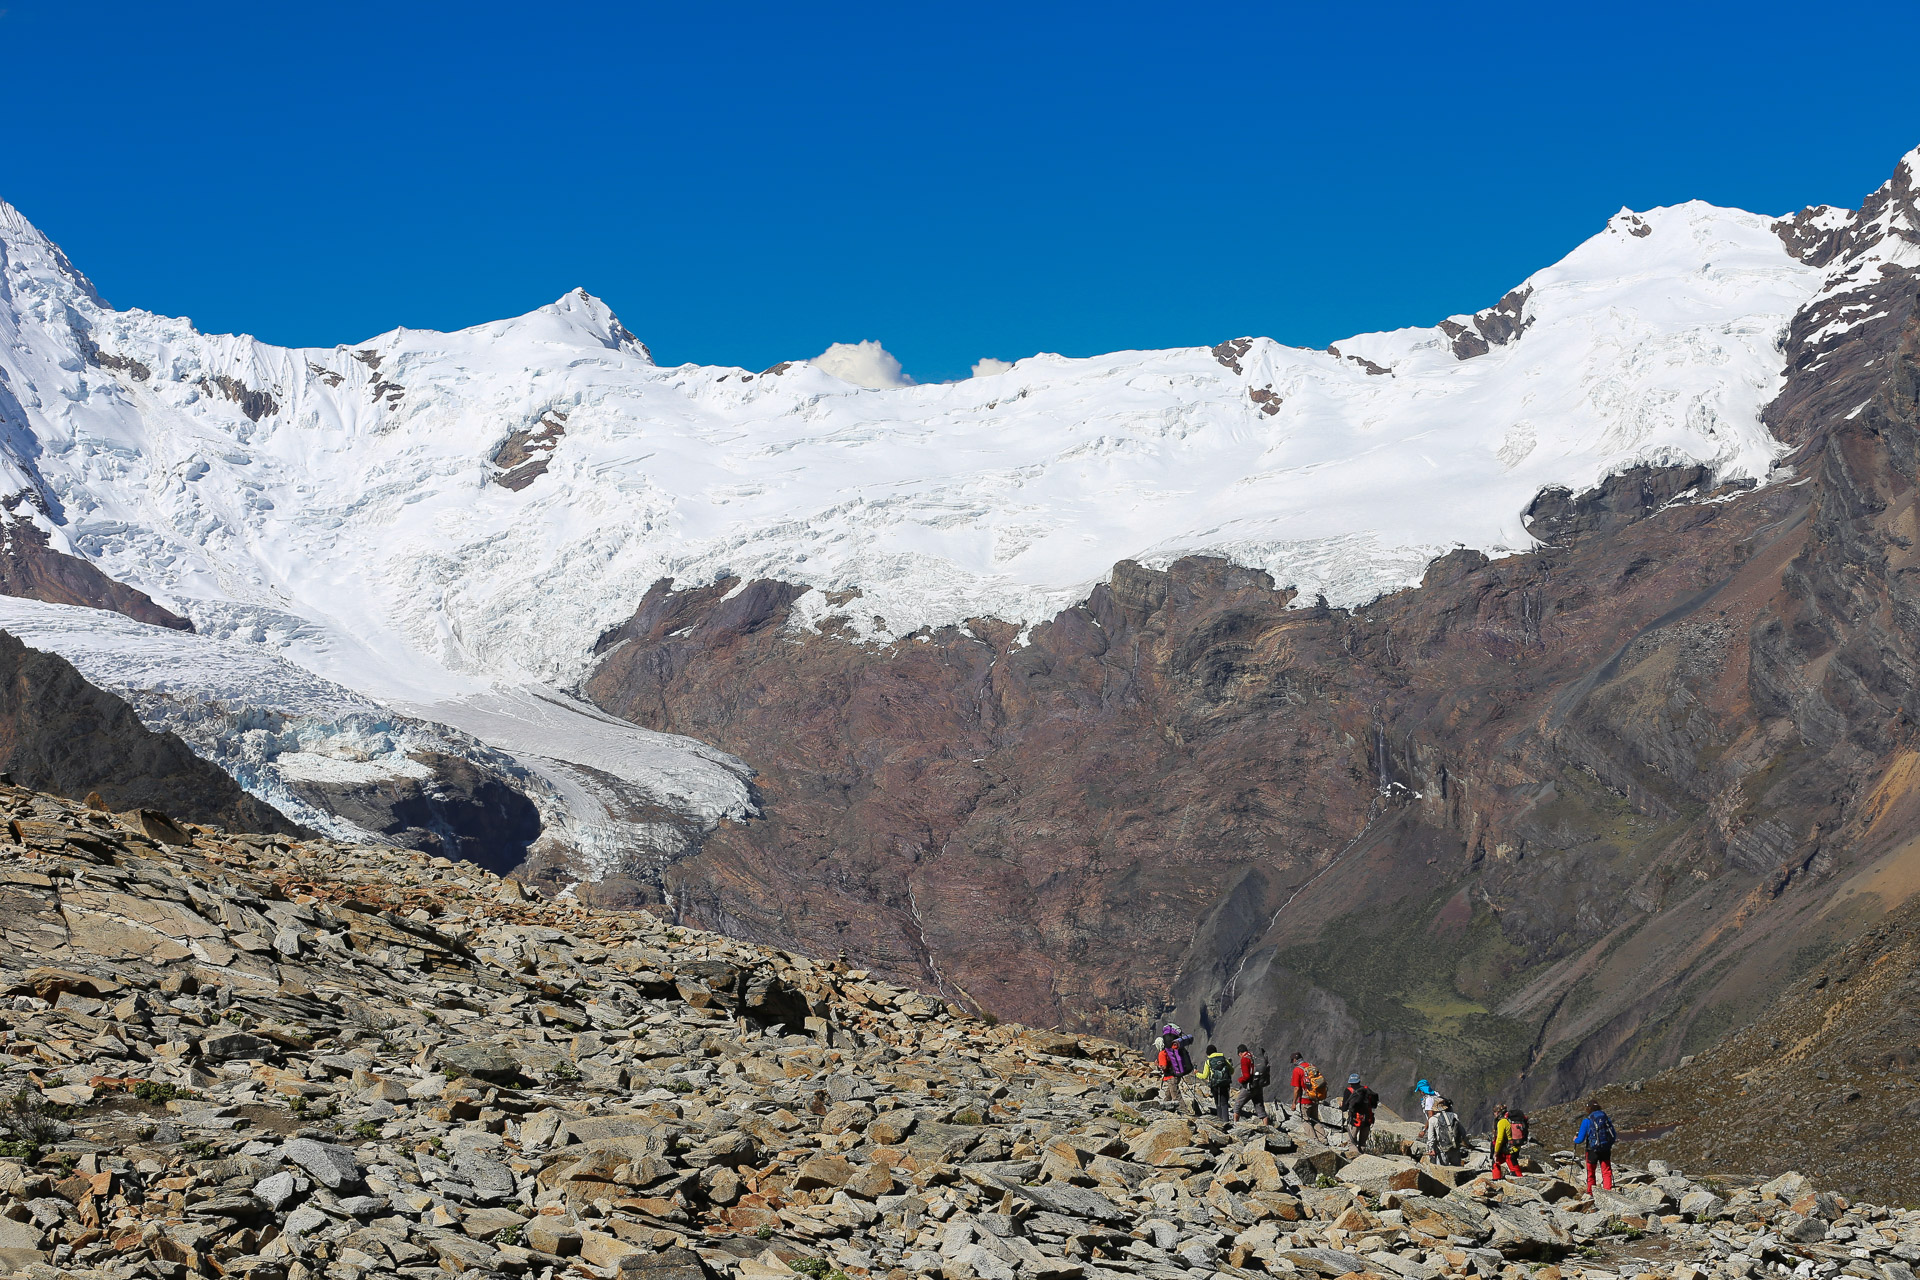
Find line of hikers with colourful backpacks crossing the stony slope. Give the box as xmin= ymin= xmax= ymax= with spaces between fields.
xmin=1156 ymin=1023 xmax=1617 ymax=1192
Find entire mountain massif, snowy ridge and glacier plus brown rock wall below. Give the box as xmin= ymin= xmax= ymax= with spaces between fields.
xmin=0 ymin=154 xmax=1920 ymax=1128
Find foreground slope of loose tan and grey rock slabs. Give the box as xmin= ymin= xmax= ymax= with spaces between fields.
xmin=0 ymin=787 xmax=1920 ymax=1280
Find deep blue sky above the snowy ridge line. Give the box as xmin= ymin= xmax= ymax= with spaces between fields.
xmin=0 ymin=0 xmax=1920 ymax=380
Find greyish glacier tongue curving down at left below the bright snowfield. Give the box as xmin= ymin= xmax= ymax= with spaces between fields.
xmin=0 ymin=595 xmax=755 ymax=879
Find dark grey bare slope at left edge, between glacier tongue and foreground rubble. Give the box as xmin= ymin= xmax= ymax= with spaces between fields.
xmin=0 ymin=631 xmax=294 ymax=831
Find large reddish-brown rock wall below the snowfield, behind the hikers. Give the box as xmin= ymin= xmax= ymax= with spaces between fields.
xmin=586 ymin=150 xmax=1920 ymax=1107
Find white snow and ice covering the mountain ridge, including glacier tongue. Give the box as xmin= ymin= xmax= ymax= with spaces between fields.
xmin=0 ymin=157 xmax=1873 ymax=873
